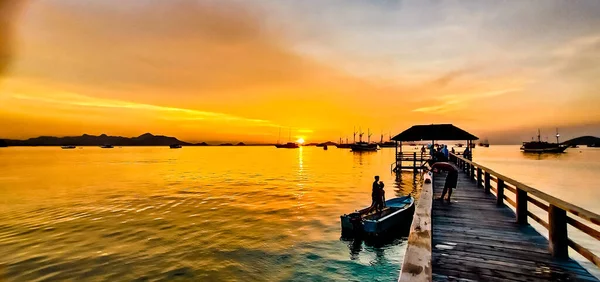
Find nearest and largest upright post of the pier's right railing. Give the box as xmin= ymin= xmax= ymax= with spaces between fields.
xmin=548 ymin=204 xmax=569 ymax=259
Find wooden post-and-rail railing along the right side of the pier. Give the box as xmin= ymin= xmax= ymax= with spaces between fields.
xmin=450 ymin=154 xmax=600 ymax=267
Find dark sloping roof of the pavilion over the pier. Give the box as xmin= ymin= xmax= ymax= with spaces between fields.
xmin=392 ymin=124 xmax=479 ymax=141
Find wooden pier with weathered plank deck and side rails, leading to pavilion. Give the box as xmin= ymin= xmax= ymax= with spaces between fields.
xmin=399 ymin=155 xmax=600 ymax=281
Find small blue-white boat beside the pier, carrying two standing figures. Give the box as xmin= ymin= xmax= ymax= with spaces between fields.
xmin=340 ymin=196 xmax=415 ymax=236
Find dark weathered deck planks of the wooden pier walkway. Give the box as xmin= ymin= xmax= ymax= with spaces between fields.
xmin=431 ymin=172 xmax=599 ymax=281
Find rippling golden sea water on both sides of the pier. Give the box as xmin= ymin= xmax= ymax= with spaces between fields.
xmin=0 ymin=145 xmax=600 ymax=281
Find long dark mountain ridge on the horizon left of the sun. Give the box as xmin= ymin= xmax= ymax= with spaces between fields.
xmin=6 ymin=133 xmax=191 ymax=146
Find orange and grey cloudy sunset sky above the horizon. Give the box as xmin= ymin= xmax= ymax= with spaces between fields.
xmin=0 ymin=0 xmax=600 ymax=144
